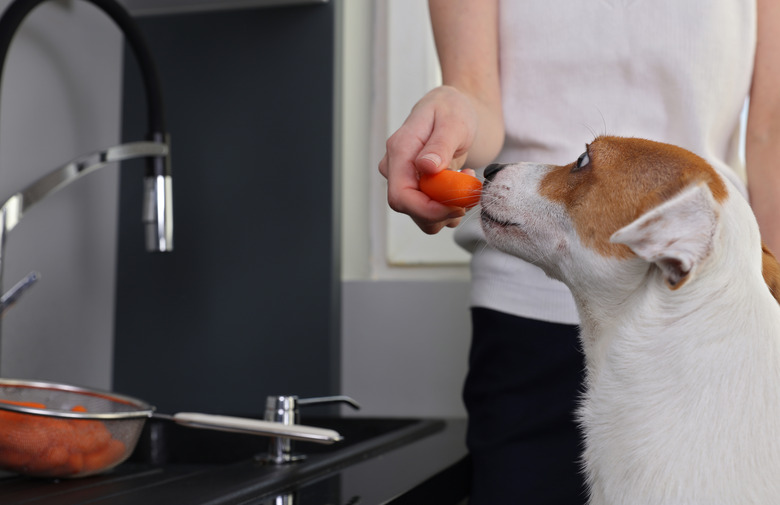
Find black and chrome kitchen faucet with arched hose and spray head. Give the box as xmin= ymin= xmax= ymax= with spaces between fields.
xmin=0 ymin=0 xmax=173 ymax=368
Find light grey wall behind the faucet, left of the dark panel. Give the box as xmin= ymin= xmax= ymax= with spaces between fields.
xmin=0 ymin=0 xmax=122 ymax=388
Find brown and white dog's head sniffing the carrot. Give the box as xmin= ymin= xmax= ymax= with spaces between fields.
xmin=482 ymin=136 xmax=772 ymax=296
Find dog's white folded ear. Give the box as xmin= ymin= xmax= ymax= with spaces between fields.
xmin=610 ymin=183 xmax=718 ymax=289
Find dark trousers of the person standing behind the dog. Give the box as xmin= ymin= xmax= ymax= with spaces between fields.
xmin=463 ymin=308 xmax=586 ymax=505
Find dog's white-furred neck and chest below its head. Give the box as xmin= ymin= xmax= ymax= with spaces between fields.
xmin=578 ymin=222 xmax=780 ymax=504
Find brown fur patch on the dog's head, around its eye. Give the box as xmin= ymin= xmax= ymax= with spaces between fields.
xmin=540 ymin=136 xmax=728 ymax=258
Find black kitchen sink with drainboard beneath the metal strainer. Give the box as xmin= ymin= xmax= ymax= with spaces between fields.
xmin=0 ymin=416 xmax=453 ymax=505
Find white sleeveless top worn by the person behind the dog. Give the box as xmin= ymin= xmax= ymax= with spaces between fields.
xmin=456 ymin=0 xmax=756 ymax=324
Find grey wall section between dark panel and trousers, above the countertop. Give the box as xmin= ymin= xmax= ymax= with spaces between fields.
xmin=341 ymin=281 xmax=471 ymax=417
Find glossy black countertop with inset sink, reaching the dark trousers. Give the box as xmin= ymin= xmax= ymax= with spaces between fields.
xmin=0 ymin=418 xmax=468 ymax=505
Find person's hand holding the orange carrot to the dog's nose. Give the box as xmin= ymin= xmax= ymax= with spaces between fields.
xmin=379 ymin=86 xmax=477 ymax=234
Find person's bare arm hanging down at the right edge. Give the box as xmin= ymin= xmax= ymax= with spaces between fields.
xmin=745 ymin=0 xmax=780 ymax=254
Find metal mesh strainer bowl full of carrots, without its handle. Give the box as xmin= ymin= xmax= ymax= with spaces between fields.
xmin=0 ymin=379 xmax=154 ymax=478
